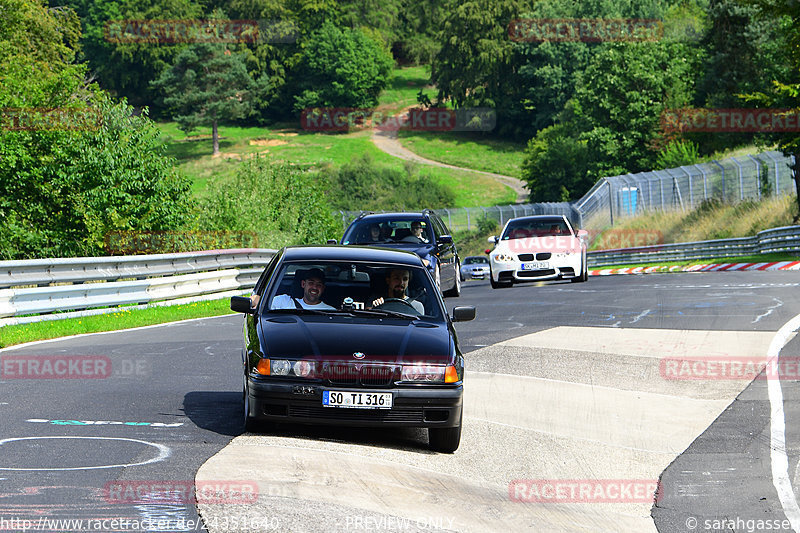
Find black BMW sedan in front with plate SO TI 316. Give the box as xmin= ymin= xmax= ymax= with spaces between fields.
xmin=231 ymin=246 xmax=475 ymax=453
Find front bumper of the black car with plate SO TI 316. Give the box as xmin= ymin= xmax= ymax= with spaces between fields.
xmin=248 ymin=378 xmax=464 ymax=428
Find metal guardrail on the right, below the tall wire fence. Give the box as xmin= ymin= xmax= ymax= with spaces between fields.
xmin=587 ymin=226 xmax=800 ymax=267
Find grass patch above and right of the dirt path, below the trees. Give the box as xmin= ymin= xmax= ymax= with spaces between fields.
xmin=399 ymin=131 xmax=525 ymax=178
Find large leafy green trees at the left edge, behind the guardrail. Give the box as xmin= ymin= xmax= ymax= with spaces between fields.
xmin=0 ymin=0 xmax=189 ymax=259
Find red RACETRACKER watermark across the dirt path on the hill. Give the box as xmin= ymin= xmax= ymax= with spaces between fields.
xmin=300 ymin=107 xmax=497 ymax=132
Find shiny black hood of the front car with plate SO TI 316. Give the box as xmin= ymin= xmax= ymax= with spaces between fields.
xmin=261 ymin=314 xmax=452 ymax=362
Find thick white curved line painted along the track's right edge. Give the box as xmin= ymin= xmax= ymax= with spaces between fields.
xmin=767 ymin=315 xmax=800 ymax=532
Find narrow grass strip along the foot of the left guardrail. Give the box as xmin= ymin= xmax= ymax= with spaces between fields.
xmin=0 ymin=298 xmax=233 ymax=348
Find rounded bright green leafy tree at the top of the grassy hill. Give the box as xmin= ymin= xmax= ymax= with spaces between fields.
xmin=294 ymin=21 xmax=394 ymax=111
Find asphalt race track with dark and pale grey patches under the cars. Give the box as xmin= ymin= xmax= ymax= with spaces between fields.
xmin=0 ymin=272 xmax=800 ymax=532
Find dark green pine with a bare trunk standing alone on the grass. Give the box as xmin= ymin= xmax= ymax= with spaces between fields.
xmin=153 ymin=43 xmax=268 ymax=155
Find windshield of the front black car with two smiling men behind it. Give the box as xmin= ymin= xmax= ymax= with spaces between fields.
xmin=265 ymin=261 xmax=443 ymax=321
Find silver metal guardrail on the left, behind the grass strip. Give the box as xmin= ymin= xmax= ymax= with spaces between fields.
xmin=0 ymin=249 xmax=275 ymax=325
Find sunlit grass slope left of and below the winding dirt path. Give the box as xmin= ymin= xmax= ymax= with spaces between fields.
xmin=158 ymin=122 xmax=516 ymax=207
